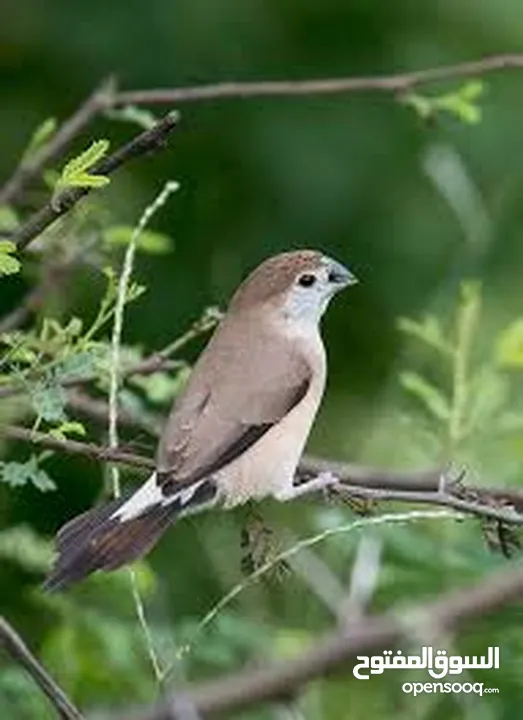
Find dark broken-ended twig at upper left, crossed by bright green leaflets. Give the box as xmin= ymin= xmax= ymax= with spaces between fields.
xmin=10 ymin=112 xmax=177 ymax=250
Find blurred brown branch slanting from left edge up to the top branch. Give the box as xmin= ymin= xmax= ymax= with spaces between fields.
xmin=0 ymin=78 xmax=116 ymax=205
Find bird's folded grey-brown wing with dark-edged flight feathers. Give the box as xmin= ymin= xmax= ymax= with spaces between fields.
xmin=157 ymin=321 xmax=312 ymax=494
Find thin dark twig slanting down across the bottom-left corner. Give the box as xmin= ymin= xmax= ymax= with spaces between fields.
xmin=0 ymin=615 xmax=83 ymax=720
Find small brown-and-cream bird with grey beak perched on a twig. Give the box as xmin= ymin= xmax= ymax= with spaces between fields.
xmin=44 ymin=249 xmax=357 ymax=591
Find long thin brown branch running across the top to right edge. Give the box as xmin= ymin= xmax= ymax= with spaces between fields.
xmin=114 ymin=54 xmax=523 ymax=106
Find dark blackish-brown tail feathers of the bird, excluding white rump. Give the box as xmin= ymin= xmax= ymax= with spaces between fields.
xmin=43 ymin=498 xmax=178 ymax=592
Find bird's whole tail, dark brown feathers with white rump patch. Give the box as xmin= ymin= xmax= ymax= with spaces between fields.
xmin=43 ymin=474 xmax=216 ymax=592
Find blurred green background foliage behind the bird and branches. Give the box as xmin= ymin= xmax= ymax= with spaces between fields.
xmin=0 ymin=0 xmax=523 ymax=720
